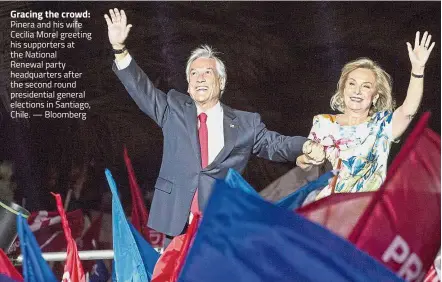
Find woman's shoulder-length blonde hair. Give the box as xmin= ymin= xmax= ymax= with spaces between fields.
xmin=330 ymin=58 xmax=394 ymax=116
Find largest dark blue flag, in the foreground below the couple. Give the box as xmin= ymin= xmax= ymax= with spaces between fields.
xmin=179 ymin=173 xmax=403 ymax=282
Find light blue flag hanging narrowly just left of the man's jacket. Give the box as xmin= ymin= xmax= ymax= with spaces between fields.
xmin=106 ymin=169 xmax=159 ymax=282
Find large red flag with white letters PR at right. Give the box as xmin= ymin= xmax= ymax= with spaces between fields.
xmin=297 ymin=114 xmax=441 ymax=281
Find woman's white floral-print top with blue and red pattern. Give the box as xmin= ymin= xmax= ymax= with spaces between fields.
xmin=308 ymin=111 xmax=393 ymax=199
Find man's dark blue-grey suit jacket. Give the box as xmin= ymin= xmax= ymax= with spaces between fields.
xmin=113 ymin=59 xmax=307 ymax=236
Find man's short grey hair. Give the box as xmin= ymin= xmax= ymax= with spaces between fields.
xmin=186 ymin=45 xmax=227 ymax=98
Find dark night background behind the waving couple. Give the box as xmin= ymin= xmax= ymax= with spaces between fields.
xmin=0 ymin=2 xmax=441 ymax=209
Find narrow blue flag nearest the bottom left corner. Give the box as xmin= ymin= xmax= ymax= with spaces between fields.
xmin=17 ymin=215 xmax=59 ymax=282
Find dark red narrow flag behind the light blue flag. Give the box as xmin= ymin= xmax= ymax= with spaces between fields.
xmin=124 ymin=147 xmax=164 ymax=248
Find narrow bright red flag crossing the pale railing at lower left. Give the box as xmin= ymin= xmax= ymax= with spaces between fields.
xmin=52 ymin=193 xmax=86 ymax=282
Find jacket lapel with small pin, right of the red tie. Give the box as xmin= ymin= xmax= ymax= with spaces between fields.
xmin=204 ymin=104 xmax=238 ymax=170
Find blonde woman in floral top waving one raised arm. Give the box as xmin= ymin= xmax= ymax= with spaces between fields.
xmin=296 ymin=32 xmax=435 ymax=199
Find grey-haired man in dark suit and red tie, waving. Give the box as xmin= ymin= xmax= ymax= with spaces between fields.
xmin=105 ymin=9 xmax=324 ymax=239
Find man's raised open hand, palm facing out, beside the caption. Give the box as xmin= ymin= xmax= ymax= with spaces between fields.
xmin=104 ymin=8 xmax=132 ymax=50
